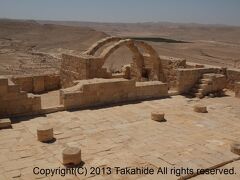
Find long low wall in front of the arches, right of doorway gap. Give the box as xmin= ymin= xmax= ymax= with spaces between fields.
xmin=60 ymin=79 xmax=168 ymax=109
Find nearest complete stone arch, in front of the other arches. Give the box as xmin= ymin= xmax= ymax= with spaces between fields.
xmin=100 ymin=39 xmax=144 ymax=81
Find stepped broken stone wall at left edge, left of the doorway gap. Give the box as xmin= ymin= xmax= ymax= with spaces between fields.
xmin=0 ymin=77 xmax=41 ymax=118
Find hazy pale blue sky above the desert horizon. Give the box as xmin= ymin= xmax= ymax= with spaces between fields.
xmin=0 ymin=0 xmax=240 ymax=26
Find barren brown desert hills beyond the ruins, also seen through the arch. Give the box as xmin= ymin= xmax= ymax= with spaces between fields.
xmin=0 ymin=20 xmax=240 ymax=74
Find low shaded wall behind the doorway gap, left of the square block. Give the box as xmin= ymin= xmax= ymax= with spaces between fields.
xmin=11 ymin=74 xmax=60 ymax=94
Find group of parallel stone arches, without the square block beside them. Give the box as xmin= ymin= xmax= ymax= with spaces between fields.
xmin=83 ymin=36 xmax=166 ymax=82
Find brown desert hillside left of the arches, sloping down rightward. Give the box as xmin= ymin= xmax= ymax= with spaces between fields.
xmin=0 ymin=20 xmax=106 ymax=74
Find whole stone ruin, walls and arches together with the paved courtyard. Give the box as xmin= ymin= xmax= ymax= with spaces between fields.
xmin=0 ymin=37 xmax=240 ymax=179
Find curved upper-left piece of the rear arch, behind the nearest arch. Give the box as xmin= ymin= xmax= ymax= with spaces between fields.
xmin=84 ymin=36 xmax=122 ymax=56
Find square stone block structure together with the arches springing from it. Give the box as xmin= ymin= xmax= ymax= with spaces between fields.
xmin=60 ymin=37 xmax=165 ymax=88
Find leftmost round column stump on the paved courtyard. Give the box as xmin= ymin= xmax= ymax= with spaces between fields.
xmin=37 ymin=124 xmax=53 ymax=142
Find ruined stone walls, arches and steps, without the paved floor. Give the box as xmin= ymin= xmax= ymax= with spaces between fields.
xmin=0 ymin=37 xmax=240 ymax=118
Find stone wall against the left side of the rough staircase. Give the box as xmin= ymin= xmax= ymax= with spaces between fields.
xmin=177 ymin=68 xmax=223 ymax=93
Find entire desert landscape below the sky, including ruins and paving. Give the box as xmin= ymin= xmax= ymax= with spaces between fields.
xmin=0 ymin=11 xmax=240 ymax=180
